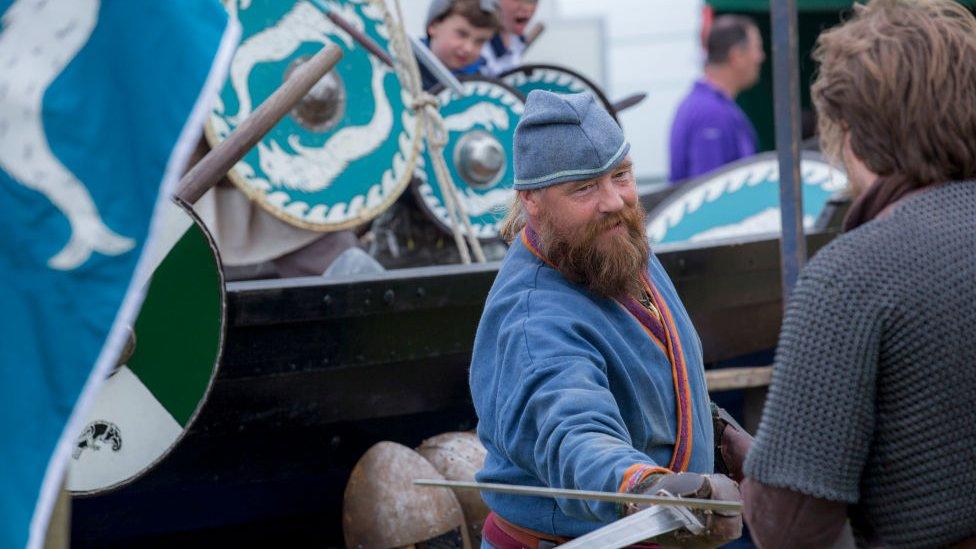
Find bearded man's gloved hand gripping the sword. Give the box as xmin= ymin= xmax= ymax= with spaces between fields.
xmin=627 ymin=473 xmax=742 ymax=548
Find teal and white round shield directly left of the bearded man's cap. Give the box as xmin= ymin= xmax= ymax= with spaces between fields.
xmin=414 ymin=77 xmax=524 ymax=239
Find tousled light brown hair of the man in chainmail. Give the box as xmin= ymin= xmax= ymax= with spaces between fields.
xmin=811 ymin=0 xmax=976 ymax=190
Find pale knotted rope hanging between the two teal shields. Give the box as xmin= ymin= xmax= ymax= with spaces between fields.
xmin=380 ymin=0 xmax=485 ymax=264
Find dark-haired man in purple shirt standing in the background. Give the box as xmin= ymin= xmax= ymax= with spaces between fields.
xmin=668 ymin=15 xmax=766 ymax=184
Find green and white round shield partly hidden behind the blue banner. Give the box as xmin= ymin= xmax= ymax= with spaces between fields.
xmin=68 ymin=199 xmax=225 ymax=495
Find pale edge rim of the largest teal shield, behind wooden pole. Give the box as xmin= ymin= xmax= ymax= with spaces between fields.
xmin=203 ymin=0 xmax=423 ymax=233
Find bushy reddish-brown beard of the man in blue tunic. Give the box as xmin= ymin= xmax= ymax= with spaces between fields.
xmin=538 ymin=204 xmax=650 ymax=298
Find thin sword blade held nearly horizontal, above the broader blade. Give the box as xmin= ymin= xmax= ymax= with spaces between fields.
xmin=413 ymin=479 xmax=742 ymax=512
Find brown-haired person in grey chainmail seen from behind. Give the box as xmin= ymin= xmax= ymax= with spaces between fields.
xmin=742 ymin=0 xmax=976 ymax=548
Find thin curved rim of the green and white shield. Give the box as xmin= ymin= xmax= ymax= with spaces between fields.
xmin=69 ymin=196 xmax=227 ymax=498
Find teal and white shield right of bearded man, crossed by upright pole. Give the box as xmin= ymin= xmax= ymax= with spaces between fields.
xmin=647 ymin=152 xmax=847 ymax=244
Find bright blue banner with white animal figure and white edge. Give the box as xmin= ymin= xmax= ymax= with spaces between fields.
xmin=0 ymin=0 xmax=240 ymax=547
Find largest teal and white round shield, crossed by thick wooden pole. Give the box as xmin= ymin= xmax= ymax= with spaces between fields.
xmin=207 ymin=0 xmax=421 ymax=231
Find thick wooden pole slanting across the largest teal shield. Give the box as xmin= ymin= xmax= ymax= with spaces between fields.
xmin=173 ymin=44 xmax=342 ymax=204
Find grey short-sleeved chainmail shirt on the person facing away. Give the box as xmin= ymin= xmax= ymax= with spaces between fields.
xmin=745 ymin=182 xmax=976 ymax=547
